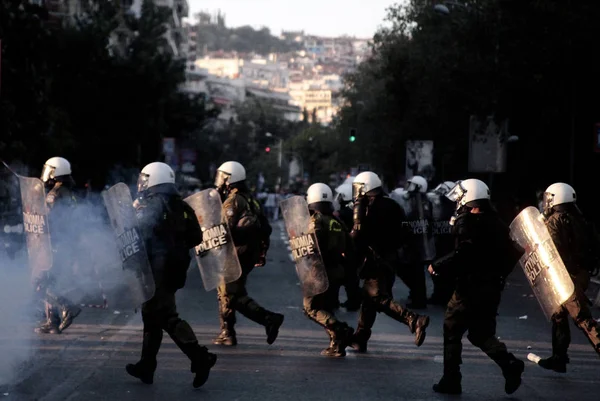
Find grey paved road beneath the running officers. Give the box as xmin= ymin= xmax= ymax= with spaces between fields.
xmin=0 ymin=220 xmax=600 ymax=401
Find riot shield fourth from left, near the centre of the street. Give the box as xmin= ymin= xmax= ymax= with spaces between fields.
xmin=279 ymin=196 xmax=329 ymax=297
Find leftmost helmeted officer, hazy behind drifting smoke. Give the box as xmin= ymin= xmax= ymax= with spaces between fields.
xmin=35 ymin=157 xmax=81 ymax=334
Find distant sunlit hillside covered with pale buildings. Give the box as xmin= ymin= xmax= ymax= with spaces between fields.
xmin=185 ymin=9 xmax=369 ymax=125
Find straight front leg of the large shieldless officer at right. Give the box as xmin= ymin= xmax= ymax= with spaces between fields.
xmin=433 ymin=294 xmax=468 ymax=394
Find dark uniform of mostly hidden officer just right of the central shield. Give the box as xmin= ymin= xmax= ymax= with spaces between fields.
xmin=337 ymin=202 xmax=362 ymax=311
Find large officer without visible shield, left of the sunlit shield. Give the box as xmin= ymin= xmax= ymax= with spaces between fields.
xmin=429 ymin=179 xmax=525 ymax=394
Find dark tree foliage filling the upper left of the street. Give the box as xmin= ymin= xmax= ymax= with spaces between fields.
xmin=0 ymin=0 xmax=204 ymax=185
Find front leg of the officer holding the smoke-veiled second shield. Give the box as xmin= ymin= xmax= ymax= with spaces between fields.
xmin=125 ymin=291 xmax=164 ymax=384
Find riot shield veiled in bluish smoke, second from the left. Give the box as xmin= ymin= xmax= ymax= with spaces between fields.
xmin=102 ymin=183 xmax=155 ymax=309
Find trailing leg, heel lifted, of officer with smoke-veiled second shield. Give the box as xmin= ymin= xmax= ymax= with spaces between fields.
xmin=161 ymin=292 xmax=217 ymax=388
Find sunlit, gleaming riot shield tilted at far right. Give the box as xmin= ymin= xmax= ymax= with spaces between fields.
xmin=510 ymin=206 xmax=575 ymax=320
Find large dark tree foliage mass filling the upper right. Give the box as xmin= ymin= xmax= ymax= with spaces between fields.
xmin=330 ymin=0 xmax=600 ymax=206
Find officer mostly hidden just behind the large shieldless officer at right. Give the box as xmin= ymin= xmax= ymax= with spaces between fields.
xmin=427 ymin=181 xmax=455 ymax=306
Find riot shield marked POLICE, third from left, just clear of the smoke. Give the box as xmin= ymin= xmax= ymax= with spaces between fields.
xmin=185 ymin=189 xmax=242 ymax=291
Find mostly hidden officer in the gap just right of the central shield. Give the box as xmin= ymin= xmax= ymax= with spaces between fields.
xmin=334 ymin=184 xmax=362 ymax=312
